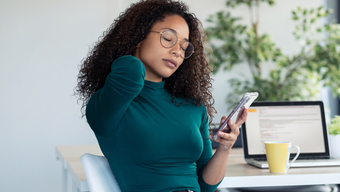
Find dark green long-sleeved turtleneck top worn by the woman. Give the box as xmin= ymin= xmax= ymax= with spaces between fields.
xmin=86 ymin=56 xmax=218 ymax=192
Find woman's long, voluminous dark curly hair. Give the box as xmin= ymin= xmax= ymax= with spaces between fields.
xmin=76 ymin=0 xmax=216 ymax=125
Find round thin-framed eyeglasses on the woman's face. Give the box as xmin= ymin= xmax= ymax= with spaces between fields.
xmin=150 ymin=29 xmax=194 ymax=59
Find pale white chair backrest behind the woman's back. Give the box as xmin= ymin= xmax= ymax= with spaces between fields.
xmin=80 ymin=153 xmax=120 ymax=192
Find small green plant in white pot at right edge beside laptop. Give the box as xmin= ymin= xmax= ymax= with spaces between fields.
xmin=328 ymin=115 xmax=340 ymax=157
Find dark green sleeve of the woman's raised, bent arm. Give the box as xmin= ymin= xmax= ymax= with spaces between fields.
xmin=86 ymin=56 xmax=145 ymax=136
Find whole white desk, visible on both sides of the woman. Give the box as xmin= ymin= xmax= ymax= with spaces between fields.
xmin=56 ymin=145 xmax=340 ymax=192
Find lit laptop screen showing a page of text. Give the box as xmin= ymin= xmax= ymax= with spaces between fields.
xmin=246 ymin=105 xmax=325 ymax=155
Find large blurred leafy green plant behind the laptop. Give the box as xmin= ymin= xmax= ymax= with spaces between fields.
xmin=206 ymin=0 xmax=340 ymax=110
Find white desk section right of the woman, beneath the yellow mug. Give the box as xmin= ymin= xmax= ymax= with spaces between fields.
xmin=219 ymin=152 xmax=340 ymax=188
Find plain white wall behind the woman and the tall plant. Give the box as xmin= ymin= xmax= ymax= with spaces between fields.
xmin=0 ymin=0 xmax=322 ymax=192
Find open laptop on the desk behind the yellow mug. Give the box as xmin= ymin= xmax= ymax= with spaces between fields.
xmin=241 ymin=101 xmax=340 ymax=168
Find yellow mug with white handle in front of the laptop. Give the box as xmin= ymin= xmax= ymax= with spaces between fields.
xmin=264 ymin=142 xmax=300 ymax=173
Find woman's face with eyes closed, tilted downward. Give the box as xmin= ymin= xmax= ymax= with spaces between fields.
xmin=134 ymin=15 xmax=189 ymax=82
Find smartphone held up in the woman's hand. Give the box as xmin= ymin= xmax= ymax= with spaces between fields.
xmin=213 ymin=92 xmax=259 ymax=140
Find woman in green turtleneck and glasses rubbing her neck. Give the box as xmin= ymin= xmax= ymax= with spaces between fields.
xmin=77 ymin=0 xmax=247 ymax=192
